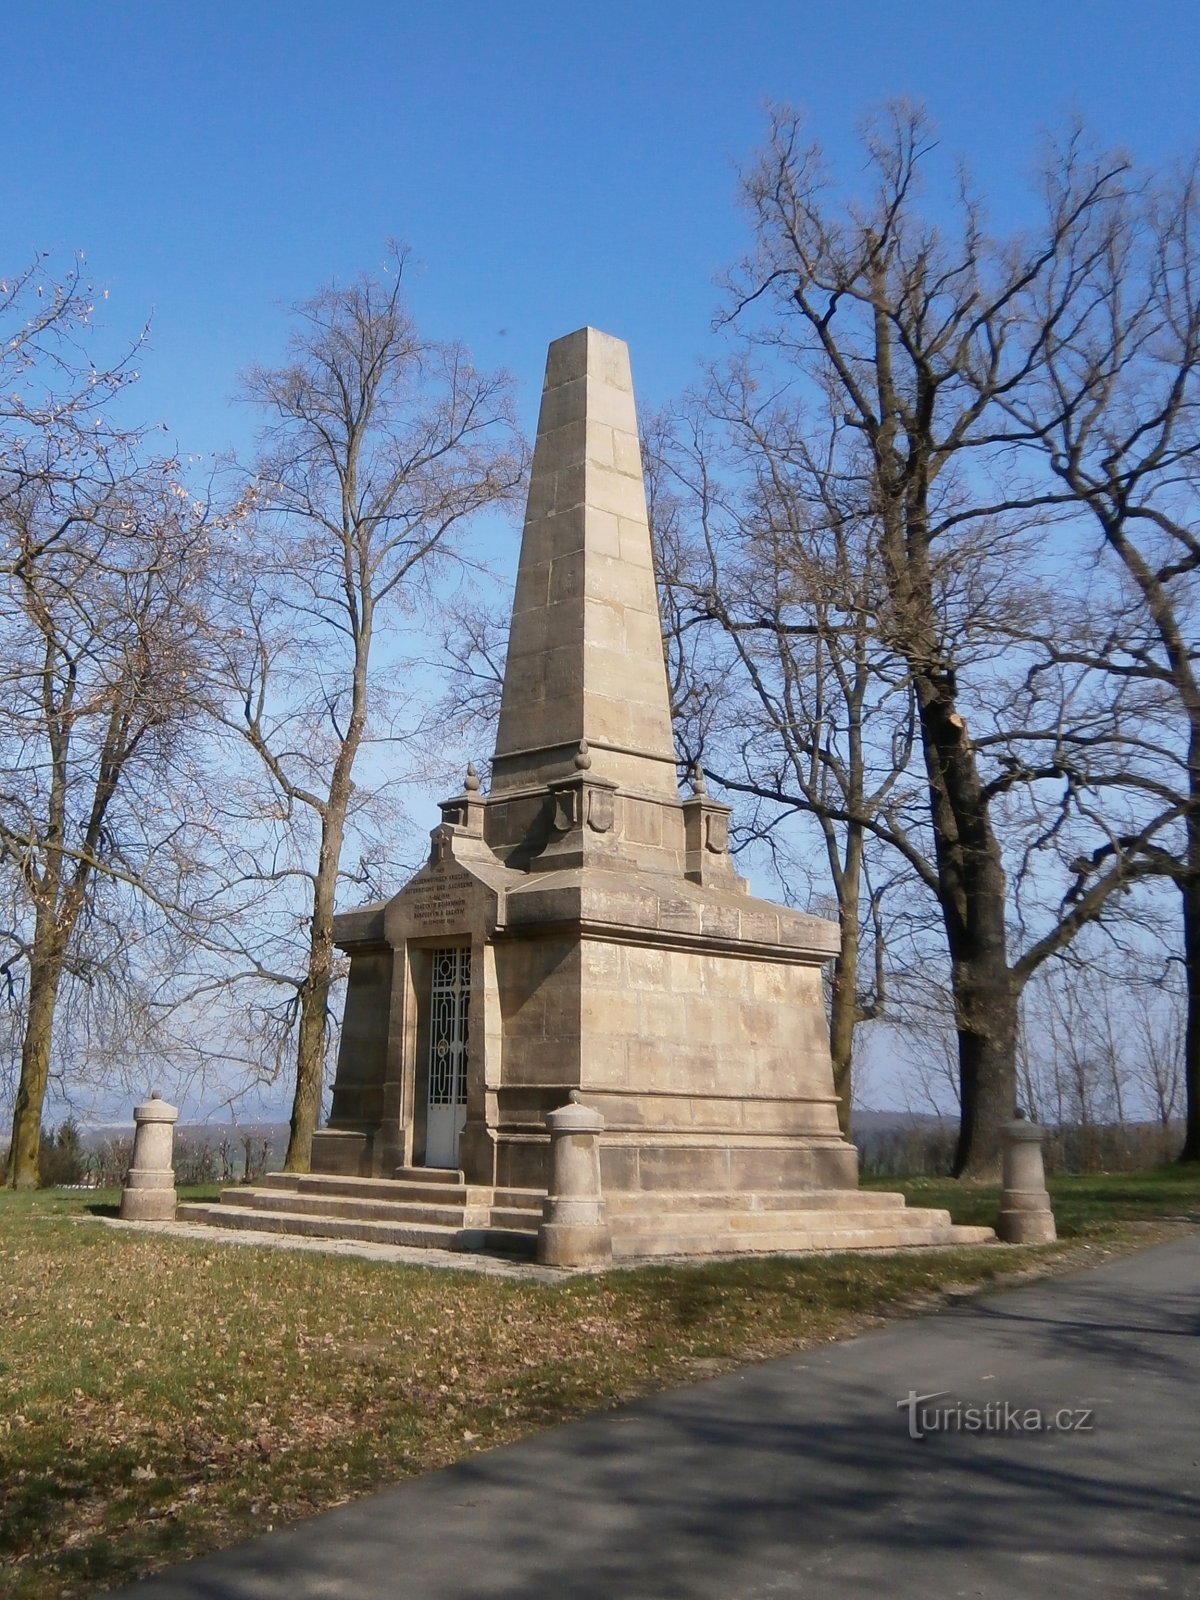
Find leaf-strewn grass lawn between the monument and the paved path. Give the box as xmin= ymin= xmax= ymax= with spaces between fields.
xmin=0 ymin=1174 xmax=1200 ymax=1600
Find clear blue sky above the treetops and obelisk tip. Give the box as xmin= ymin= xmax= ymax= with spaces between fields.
xmin=9 ymin=0 xmax=1200 ymax=467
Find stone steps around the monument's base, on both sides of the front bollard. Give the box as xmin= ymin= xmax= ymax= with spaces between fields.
xmin=176 ymin=1166 xmax=995 ymax=1261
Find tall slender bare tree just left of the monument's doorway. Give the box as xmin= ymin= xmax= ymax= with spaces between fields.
xmin=216 ymin=253 xmax=525 ymax=1171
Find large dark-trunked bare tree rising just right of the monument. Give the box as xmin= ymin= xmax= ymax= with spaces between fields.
xmin=730 ymin=106 xmax=1162 ymax=1173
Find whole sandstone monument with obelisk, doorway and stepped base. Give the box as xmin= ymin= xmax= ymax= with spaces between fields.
xmin=183 ymin=328 xmax=992 ymax=1259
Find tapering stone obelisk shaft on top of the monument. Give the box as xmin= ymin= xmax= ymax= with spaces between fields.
xmin=491 ymin=328 xmax=678 ymax=800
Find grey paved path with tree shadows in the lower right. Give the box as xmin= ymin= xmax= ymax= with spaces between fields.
xmin=115 ymin=1237 xmax=1200 ymax=1600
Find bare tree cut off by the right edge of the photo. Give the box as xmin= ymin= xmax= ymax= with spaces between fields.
xmin=1006 ymin=152 xmax=1200 ymax=1162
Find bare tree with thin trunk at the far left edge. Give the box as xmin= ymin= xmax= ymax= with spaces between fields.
xmin=0 ymin=450 xmax=212 ymax=1187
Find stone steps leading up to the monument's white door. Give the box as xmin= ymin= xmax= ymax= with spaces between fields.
xmin=176 ymin=1166 xmax=544 ymax=1256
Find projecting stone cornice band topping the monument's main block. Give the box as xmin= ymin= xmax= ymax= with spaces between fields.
xmin=504 ymin=867 xmax=838 ymax=962
